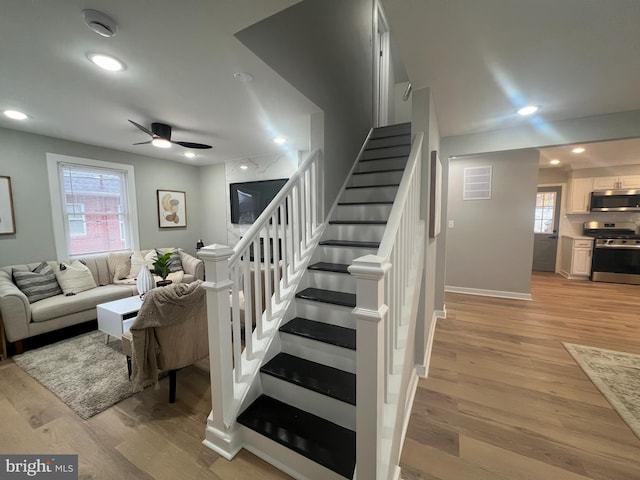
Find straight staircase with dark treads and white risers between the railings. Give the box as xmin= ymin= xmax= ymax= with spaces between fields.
xmin=200 ymin=124 xmax=419 ymax=480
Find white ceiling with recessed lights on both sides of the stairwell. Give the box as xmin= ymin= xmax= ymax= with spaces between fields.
xmin=0 ymin=0 xmax=640 ymax=169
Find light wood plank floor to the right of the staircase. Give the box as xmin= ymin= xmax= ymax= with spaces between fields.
xmin=402 ymin=274 xmax=640 ymax=480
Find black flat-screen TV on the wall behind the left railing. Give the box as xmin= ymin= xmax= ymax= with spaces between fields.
xmin=229 ymin=178 xmax=288 ymax=224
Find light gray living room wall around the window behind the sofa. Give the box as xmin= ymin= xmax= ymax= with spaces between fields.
xmin=0 ymin=128 xmax=201 ymax=265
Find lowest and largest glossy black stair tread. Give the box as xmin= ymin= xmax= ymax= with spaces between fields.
xmin=238 ymin=395 xmax=356 ymax=479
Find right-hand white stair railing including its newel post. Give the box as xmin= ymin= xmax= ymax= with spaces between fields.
xmin=349 ymin=133 xmax=425 ymax=480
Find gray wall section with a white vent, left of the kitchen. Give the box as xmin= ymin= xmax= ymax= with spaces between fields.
xmin=446 ymin=150 xmax=538 ymax=294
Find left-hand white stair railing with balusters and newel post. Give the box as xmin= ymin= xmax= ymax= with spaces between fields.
xmin=198 ymin=149 xmax=324 ymax=459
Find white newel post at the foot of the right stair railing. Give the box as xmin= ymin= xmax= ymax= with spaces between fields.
xmin=349 ymin=255 xmax=391 ymax=480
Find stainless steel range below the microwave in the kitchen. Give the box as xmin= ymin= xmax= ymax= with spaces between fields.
xmin=583 ymin=222 xmax=640 ymax=285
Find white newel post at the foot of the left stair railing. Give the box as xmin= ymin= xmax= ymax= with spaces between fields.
xmin=198 ymin=245 xmax=242 ymax=460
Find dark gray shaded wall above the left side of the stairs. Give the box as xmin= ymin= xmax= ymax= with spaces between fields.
xmin=236 ymin=0 xmax=373 ymax=212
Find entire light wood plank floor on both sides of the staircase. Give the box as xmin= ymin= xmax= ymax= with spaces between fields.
xmin=0 ymin=274 xmax=640 ymax=480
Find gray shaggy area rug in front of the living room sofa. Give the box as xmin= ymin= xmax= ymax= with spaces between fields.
xmin=13 ymin=331 xmax=133 ymax=420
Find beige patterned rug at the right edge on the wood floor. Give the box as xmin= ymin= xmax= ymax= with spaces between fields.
xmin=563 ymin=343 xmax=640 ymax=438
